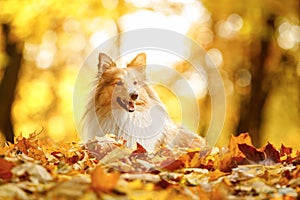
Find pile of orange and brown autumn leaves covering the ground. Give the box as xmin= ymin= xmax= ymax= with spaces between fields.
xmin=0 ymin=134 xmax=300 ymax=199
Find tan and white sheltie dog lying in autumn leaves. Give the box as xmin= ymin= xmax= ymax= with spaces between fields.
xmin=82 ymin=53 xmax=205 ymax=152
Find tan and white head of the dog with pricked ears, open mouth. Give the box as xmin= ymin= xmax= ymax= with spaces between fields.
xmin=96 ymin=53 xmax=150 ymax=112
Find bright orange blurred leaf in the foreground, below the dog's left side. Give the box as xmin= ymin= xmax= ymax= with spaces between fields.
xmin=91 ymin=165 xmax=120 ymax=194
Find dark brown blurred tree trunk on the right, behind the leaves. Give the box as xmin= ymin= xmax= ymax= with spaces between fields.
xmin=236 ymin=15 xmax=275 ymax=147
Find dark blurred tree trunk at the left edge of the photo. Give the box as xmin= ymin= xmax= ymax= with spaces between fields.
xmin=0 ymin=24 xmax=22 ymax=142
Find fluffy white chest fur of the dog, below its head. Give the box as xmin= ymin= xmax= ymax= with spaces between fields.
xmin=83 ymin=101 xmax=170 ymax=151
